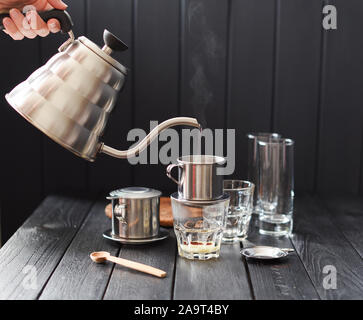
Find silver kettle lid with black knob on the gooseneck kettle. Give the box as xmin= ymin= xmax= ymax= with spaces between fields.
xmin=78 ymin=29 xmax=128 ymax=75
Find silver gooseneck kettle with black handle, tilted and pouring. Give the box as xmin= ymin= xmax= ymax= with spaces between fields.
xmin=0 ymin=10 xmax=200 ymax=161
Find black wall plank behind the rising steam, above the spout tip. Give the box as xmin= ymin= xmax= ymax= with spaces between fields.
xmin=180 ymin=0 xmax=229 ymax=129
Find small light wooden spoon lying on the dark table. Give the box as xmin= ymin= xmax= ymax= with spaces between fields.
xmin=90 ymin=251 xmax=166 ymax=278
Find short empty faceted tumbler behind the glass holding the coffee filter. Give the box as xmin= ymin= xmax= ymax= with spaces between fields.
xmin=223 ymin=180 xmax=255 ymax=243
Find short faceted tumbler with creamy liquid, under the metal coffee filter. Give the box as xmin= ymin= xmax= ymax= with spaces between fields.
xmin=170 ymin=192 xmax=229 ymax=260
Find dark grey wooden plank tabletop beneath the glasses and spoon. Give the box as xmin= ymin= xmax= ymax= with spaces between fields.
xmin=0 ymin=195 xmax=363 ymax=300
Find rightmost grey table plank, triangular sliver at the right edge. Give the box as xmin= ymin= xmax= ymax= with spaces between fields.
xmin=323 ymin=196 xmax=363 ymax=260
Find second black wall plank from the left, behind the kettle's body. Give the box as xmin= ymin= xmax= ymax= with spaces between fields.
xmin=40 ymin=0 xmax=87 ymax=194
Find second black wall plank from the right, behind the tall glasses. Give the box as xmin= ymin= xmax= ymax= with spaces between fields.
xmin=272 ymin=0 xmax=322 ymax=191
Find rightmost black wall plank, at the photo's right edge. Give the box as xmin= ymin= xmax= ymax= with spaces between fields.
xmin=317 ymin=0 xmax=363 ymax=193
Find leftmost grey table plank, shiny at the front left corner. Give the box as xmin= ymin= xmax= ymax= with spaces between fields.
xmin=0 ymin=196 xmax=92 ymax=299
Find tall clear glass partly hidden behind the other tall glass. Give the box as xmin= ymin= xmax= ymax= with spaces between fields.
xmin=247 ymin=132 xmax=281 ymax=214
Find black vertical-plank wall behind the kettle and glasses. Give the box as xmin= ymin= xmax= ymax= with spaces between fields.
xmin=0 ymin=0 xmax=363 ymax=239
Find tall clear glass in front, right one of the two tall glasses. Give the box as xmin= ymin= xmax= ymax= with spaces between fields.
xmin=256 ymin=139 xmax=294 ymax=236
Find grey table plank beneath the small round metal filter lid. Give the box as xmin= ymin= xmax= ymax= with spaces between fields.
xmin=243 ymin=215 xmax=319 ymax=300
